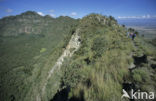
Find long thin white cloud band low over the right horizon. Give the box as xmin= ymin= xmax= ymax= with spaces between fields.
xmin=118 ymin=14 xmax=156 ymax=19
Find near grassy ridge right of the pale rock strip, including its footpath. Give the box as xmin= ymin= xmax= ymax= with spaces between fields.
xmin=51 ymin=14 xmax=156 ymax=101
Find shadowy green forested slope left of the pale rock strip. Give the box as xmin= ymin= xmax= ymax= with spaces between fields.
xmin=0 ymin=11 xmax=77 ymax=101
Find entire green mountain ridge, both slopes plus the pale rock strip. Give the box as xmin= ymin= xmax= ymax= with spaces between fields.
xmin=0 ymin=11 xmax=156 ymax=101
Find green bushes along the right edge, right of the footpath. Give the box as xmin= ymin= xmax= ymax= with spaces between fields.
xmin=131 ymin=37 xmax=156 ymax=92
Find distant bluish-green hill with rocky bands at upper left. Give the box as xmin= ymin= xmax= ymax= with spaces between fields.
xmin=0 ymin=11 xmax=75 ymax=36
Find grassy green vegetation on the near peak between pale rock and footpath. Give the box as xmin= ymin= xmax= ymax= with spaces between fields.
xmin=60 ymin=14 xmax=133 ymax=101
